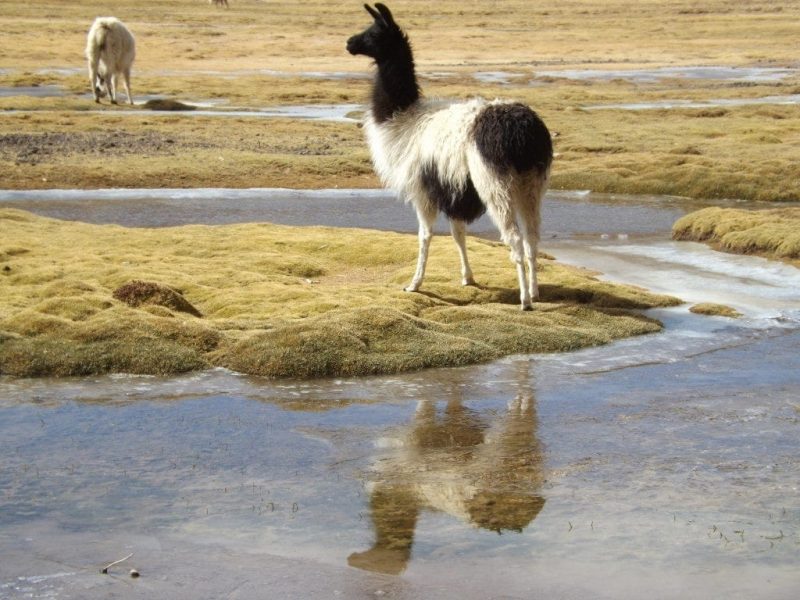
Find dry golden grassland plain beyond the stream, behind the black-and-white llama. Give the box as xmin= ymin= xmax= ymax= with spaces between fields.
xmin=0 ymin=0 xmax=800 ymax=201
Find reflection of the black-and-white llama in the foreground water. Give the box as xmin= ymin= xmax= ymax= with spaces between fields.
xmin=347 ymin=365 xmax=545 ymax=574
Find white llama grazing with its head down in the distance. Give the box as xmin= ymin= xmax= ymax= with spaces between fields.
xmin=86 ymin=17 xmax=136 ymax=104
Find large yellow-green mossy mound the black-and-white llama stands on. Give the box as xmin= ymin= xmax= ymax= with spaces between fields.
xmin=0 ymin=209 xmax=679 ymax=378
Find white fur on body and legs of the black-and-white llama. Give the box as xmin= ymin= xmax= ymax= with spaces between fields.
xmin=364 ymin=98 xmax=549 ymax=309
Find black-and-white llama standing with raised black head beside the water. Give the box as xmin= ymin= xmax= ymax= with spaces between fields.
xmin=347 ymin=4 xmax=553 ymax=310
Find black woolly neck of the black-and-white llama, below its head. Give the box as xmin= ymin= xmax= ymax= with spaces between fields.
xmin=372 ymin=42 xmax=420 ymax=123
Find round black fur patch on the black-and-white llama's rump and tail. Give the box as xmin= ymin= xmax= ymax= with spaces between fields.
xmin=473 ymin=102 xmax=553 ymax=175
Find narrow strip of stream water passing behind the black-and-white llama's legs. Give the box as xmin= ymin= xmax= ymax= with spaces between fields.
xmin=0 ymin=188 xmax=720 ymax=240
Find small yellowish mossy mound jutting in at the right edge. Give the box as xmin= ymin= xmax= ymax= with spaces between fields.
xmin=672 ymin=207 xmax=800 ymax=266
